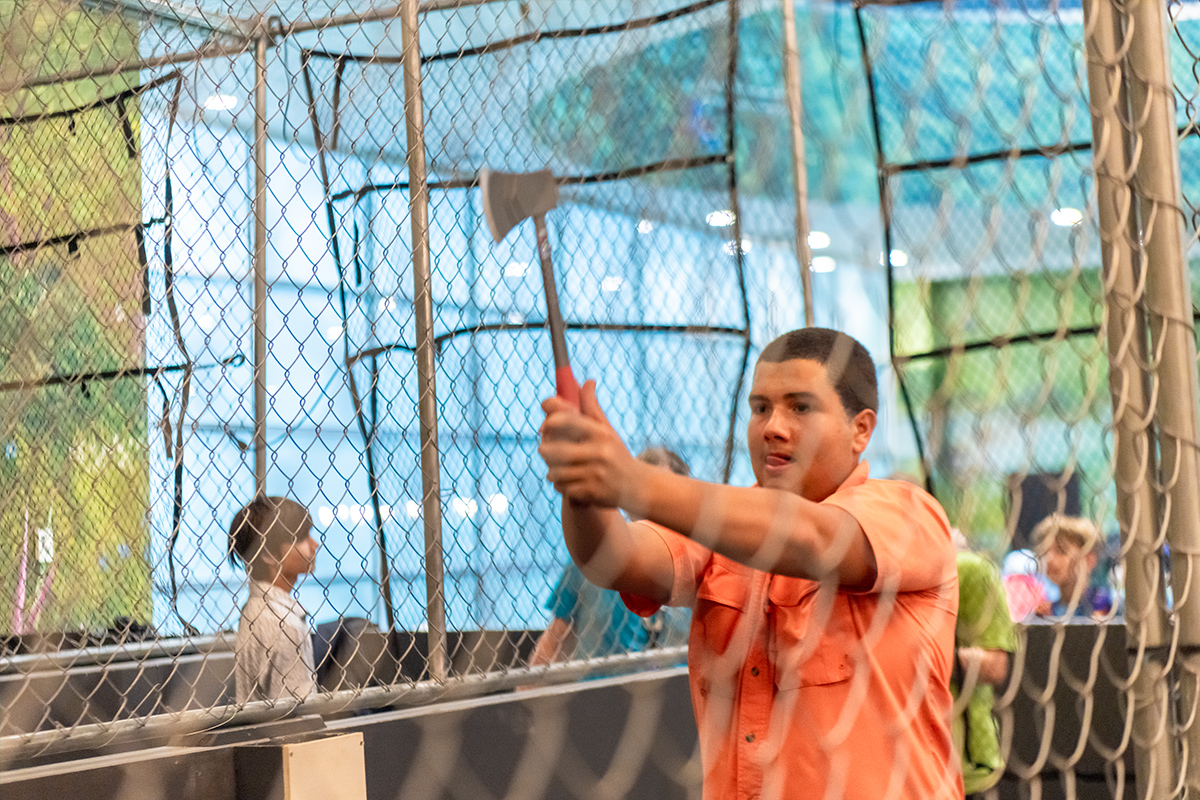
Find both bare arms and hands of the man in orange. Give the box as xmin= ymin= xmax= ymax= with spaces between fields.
xmin=540 ymin=381 xmax=876 ymax=600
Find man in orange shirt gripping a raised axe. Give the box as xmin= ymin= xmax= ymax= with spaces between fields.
xmin=540 ymin=329 xmax=962 ymax=800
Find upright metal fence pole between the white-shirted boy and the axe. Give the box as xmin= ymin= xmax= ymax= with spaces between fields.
xmin=400 ymin=0 xmax=446 ymax=681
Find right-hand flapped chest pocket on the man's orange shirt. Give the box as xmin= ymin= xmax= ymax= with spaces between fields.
xmin=768 ymin=576 xmax=857 ymax=691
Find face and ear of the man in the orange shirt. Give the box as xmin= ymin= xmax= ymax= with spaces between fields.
xmin=746 ymin=359 xmax=875 ymax=501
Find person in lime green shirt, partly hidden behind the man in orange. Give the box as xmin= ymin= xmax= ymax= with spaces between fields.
xmin=950 ymin=542 xmax=1018 ymax=796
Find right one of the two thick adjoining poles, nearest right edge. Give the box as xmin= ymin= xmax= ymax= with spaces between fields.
xmin=1127 ymin=0 xmax=1200 ymax=793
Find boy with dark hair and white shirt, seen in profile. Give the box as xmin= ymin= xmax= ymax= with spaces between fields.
xmin=229 ymin=497 xmax=320 ymax=703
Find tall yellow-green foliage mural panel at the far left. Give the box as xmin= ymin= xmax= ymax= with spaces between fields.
xmin=0 ymin=0 xmax=151 ymax=634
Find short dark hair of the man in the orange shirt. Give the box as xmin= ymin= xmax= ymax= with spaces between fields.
xmin=758 ymin=327 xmax=880 ymax=416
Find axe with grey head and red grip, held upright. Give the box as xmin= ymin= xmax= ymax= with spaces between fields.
xmin=479 ymin=167 xmax=580 ymax=408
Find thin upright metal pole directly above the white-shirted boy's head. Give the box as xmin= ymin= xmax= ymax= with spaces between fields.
xmin=253 ymin=34 xmax=268 ymax=497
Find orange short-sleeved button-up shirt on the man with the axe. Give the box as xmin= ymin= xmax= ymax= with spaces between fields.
xmin=625 ymin=462 xmax=962 ymax=800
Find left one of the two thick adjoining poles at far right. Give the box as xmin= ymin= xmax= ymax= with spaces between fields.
xmin=1084 ymin=0 xmax=1176 ymax=798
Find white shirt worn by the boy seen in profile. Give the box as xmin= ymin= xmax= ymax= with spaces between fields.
xmin=234 ymin=581 xmax=317 ymax=703
